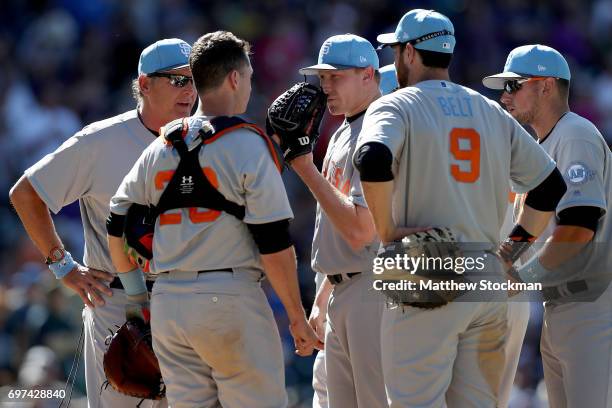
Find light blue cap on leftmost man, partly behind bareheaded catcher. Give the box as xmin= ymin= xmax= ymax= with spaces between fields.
xmin=138 ymin=38 xmax=191 ymax=75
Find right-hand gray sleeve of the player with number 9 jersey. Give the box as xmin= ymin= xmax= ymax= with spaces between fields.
xmin=508 ymin=117 xmax=555 ymax=193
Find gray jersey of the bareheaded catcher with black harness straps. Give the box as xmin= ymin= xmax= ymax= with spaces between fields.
xmin=111 ymin=117 xmax=293 ymax=274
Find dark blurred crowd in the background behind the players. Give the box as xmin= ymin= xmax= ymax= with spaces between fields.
xmin=0 ymin=0 xmax=612 ymax=408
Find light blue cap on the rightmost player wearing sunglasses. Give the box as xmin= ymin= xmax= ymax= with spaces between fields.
xmin=482 ymin=44 xmax=571 ymax=89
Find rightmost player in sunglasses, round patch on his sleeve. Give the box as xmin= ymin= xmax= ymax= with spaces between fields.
xmin=483 ymin=45 xmax=612 ymax=407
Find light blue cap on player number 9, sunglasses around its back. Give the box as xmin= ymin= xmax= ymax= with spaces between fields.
xmin=376 ymin=9 xmax=456 ymax=54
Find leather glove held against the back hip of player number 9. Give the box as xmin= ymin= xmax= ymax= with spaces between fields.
xmin=374 ymin=228 xmax=467 ymax=309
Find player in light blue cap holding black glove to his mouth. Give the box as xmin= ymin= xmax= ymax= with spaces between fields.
xmin=290 ymin=34 xmax=386 ymax=407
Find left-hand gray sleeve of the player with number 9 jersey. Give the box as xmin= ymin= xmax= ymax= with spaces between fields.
xmin=351 ymin=95 xmax=407 ymax=167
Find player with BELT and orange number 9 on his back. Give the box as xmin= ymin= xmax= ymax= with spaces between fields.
xmin=354 ymin=9 xmax=565 ymax=408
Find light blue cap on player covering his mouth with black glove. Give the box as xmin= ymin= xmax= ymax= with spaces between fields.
xmin=300 ymin=34 xmax=379 ymax=75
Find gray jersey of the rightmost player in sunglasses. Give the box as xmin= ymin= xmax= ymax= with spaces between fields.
xmin=518 ymin=112 xmax=612 ymax=292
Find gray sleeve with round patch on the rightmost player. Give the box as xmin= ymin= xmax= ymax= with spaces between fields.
xmin=557 ymin=138 xmax=607 ymax=214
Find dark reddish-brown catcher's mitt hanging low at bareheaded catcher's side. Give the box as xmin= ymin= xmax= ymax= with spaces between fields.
xmin=104 ymin=319 xmax=166 ymax=400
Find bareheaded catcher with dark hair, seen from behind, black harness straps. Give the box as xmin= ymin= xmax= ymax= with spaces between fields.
xmin=109 ymin=31 xmax=322 ymax=408
